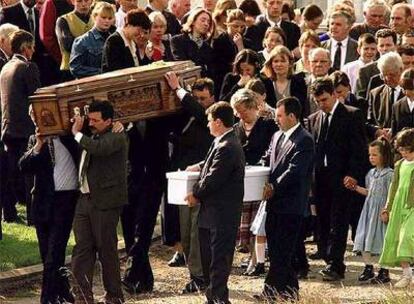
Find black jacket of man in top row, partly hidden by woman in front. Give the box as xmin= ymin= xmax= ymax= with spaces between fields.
xmin=245 ymin=15 xmax=300 ymax=52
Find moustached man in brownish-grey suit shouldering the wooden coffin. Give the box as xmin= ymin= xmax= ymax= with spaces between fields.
xmin=72 ymin=101 xmax=128 ymax=304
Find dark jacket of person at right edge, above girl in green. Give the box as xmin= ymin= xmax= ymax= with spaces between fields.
xmin=391 ymin=96 xmax=414 ymax=137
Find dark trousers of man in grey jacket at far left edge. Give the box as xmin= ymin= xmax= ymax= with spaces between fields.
xmin=2 ymin=138 xmax=30 ymax=222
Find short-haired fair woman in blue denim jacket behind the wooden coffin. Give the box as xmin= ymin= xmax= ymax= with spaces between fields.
xmin=69 ymin=2 xmax=115 ymax=78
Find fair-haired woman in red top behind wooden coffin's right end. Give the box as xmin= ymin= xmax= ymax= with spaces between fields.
xmin=148 ymin=12 xmax=173 ymax=61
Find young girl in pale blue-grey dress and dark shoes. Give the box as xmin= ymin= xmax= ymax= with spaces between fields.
xmin=353 ymin=138 xmax=393 ymax=284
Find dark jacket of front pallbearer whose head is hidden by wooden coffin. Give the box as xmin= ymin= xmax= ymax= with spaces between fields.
xmin=19 ymin=135 xmax=79 ymax=224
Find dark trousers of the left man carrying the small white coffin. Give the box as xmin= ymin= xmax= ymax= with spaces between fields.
xmin=198 ymin=227 xmax=238 ymax=304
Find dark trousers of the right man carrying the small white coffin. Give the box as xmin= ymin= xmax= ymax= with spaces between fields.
xmin=264 ymin=212 xmax=303 ymax=298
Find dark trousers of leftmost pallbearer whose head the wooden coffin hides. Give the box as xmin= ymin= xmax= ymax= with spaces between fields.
xmin=35 ymin=191 xmax=78 ymax=304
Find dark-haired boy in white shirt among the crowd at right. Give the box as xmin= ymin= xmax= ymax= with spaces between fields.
xmin=342 ymin=33 xmax=377 ymax=94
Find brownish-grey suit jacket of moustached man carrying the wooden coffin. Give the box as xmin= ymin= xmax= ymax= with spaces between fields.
xmin=79 ymin=131 xmax=128 ymax=210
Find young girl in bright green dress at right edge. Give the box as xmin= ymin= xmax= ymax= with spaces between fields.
xmin=379 ymin=129 xmax=414 ymax=288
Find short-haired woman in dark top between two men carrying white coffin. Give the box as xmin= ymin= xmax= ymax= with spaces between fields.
xmin=230 ymin=89 xmax=277 ymax=275
